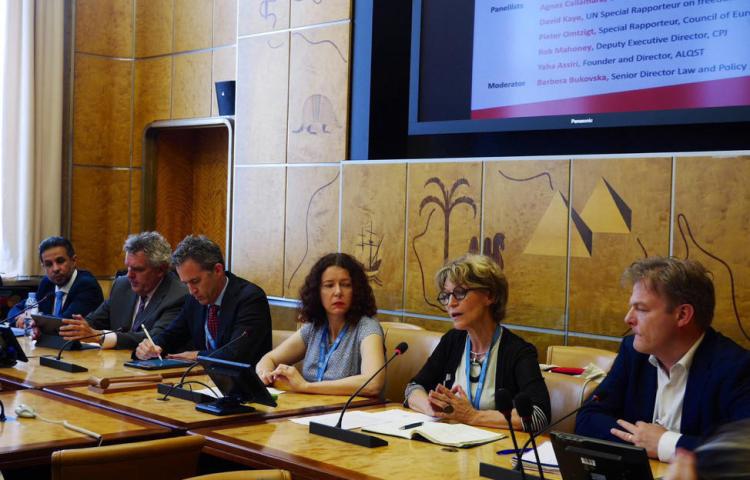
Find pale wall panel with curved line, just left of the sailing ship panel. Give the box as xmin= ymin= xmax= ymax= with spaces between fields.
xmin=284 ymin=167 xmax=340 ymax=298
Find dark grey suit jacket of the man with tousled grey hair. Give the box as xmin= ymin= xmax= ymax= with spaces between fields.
xmin=86 ymin=272 xmax=187 ymax=349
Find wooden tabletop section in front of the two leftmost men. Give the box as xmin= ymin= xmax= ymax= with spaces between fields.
xmin=0 ymin=337 xmax=200 ymax=389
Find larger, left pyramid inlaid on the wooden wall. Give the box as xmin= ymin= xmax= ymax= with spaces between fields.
xmin=523 ymin=191 xmax=593 ymax=257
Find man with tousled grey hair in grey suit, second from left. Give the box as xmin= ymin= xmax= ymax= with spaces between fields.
xmin=60 ymin=232 xmax=187 ymax=349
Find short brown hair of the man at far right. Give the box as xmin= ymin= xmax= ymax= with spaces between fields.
xmin=623 ymin=257 xmax=716 ymax=330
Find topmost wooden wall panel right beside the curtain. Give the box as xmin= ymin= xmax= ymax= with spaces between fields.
xmin=75 ymin=0 xmax=134 ymax=57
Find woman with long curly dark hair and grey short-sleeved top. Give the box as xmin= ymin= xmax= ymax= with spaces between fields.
xmin=255 ymin=253 xmax=385 ymax=396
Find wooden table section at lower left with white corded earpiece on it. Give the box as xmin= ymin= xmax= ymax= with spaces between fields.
xmin=0 ymin=390 xmax=172 ymax=469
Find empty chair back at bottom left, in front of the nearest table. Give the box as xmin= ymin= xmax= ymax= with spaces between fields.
xmin=52 ymin=435 xmax=205 ymax=480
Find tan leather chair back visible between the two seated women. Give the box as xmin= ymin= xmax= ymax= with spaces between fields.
xmin=385 ymin=328 xmax=443 ymax=402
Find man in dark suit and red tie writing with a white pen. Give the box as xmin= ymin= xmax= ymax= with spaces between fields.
xmin=134 ymin=235 xmax=271 ymax=365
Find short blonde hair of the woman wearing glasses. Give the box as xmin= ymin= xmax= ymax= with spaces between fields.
xmin=435 ymin=253 xmax=508 ymax=323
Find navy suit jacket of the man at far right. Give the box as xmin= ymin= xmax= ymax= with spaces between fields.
xmin=576 ymin=328 xmax=750 ymax=450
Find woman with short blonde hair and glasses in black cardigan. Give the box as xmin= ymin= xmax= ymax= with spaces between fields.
xmin=405 ymin=254 xmax=550 ymax=431
